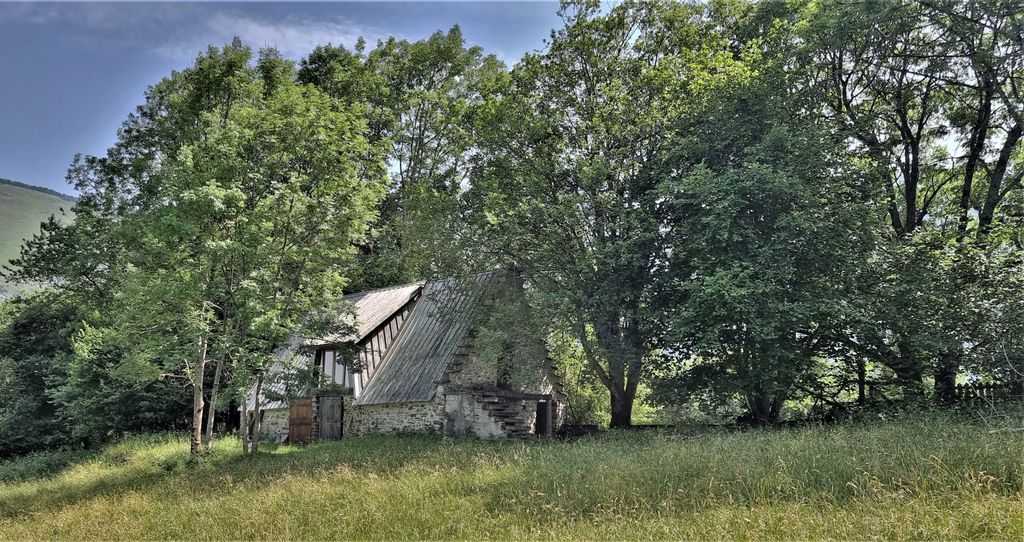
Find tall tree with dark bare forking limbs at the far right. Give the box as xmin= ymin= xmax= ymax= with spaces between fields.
xmin=798 ymin=0 xmax=1022 ymax=403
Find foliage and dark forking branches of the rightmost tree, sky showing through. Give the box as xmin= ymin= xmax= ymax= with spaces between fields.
xmin=792 ymin=1 xmax=1024 ymax=403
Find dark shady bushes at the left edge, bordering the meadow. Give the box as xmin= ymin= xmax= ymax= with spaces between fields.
xmin=0 ymin=291 xmax=188 ymax=457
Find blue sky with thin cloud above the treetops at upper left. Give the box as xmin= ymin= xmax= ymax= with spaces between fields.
xmin=0 ymin=2 xmax=560 ymax=193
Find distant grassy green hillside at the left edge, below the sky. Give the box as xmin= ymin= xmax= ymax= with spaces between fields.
xmin=0 ymin=178 xmax=75 ymax=290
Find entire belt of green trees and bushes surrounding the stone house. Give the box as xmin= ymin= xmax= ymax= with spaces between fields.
xmin=0 ymin=0 xmax=1024 ymax=455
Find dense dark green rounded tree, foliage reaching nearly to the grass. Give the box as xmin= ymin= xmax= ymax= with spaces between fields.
xmin=658 ymin=46 xmax=876 ymax=423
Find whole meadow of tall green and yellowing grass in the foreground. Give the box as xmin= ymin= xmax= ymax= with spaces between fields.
xmin=0 ymin=415 xmax=1024 ymax=540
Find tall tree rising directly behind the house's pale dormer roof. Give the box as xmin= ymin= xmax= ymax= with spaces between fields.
xmin=299 ymin=27 xmax=504 ymax=289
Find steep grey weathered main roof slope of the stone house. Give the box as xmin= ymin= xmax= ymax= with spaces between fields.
xmin=355 ymin=272 xmax=500 ymax=405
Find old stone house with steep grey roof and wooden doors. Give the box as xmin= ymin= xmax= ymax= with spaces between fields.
xmin=249 ymin=272 xmax=564 ymax=442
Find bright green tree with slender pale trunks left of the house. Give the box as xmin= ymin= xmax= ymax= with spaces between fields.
xmin=9 ymin=41 xmax=384 ymax=453
